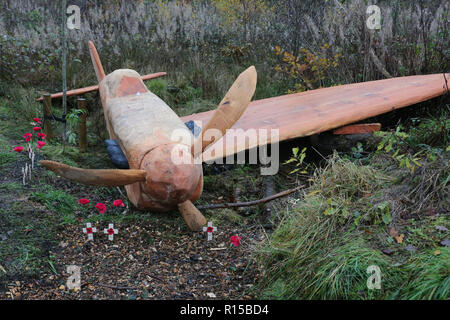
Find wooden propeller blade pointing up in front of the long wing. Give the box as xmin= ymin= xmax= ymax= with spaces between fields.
xmin=191 ymin=66 xmax=257 ymax=158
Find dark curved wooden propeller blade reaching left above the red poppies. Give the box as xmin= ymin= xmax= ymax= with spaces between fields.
xmin=39 ymin=160 xmax=146 ymax=187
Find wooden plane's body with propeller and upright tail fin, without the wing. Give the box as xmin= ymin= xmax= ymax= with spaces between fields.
xmin=40 ymin=42 xmax=256 ymax=230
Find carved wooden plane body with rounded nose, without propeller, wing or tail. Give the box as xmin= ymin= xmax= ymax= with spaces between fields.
xmin=99 ymin=69 xmax=203 ymax=211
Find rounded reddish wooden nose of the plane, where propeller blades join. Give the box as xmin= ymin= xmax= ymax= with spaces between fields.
xmin=141 ymin=144 xmax=202 ymax=205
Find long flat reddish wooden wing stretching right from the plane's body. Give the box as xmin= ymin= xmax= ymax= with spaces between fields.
xmin=182 ymin=74 xmax=450 ymax=161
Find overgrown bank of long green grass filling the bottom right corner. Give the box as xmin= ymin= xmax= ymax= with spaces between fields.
xmin=256 ymin=135 xmax=450 ymax=300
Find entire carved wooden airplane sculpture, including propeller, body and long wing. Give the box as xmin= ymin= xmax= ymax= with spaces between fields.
xmin=40 ymin=42 xmax=448 ymax=230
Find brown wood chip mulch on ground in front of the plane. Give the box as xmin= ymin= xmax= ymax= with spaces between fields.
xmin=1 ymin=221 xmax=263 ymax=300
